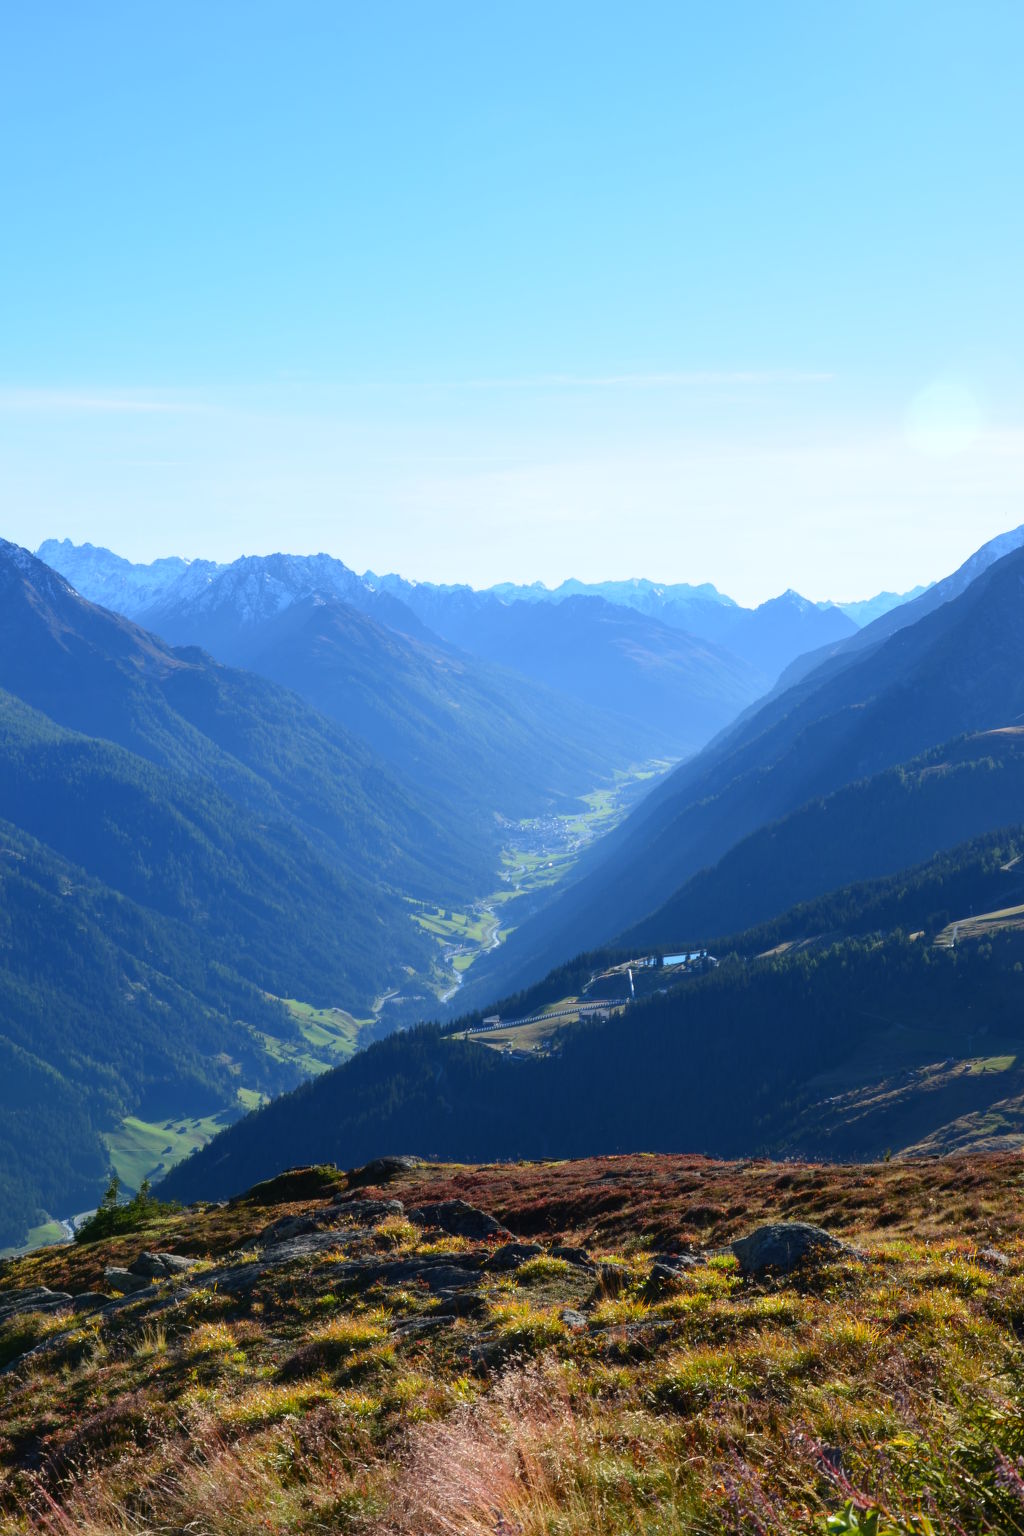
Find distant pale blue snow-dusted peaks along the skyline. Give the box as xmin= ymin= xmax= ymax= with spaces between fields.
xmin=37 ymin=539 xmax=917 ymax=697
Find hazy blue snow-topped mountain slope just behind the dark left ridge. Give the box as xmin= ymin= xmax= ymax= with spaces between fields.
xmin=33 ymin=541 xmax=706 ymax=823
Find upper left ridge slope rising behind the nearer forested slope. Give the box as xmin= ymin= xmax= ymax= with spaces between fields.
xmin=0 ymin=544 xmax=491 ymax=897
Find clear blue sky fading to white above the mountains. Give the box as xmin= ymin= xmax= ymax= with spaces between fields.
xmin=0 ymin=0 xmax=1024 ymax=602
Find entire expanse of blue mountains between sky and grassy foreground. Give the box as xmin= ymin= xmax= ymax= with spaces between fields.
xmin=8 ymin=530 xmax=1024 ymax=1241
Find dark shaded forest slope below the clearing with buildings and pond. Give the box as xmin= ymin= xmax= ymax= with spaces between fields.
xmin=163 ymin=903 xmax=1024 ymax=1200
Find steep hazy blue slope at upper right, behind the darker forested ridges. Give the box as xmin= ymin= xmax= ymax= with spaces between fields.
xmin=463 ymin=550 xmax=1024 ymax=1000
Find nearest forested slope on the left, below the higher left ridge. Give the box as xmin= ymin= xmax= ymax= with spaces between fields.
xmin=0 ymin=660 xmax=472 ymax=1246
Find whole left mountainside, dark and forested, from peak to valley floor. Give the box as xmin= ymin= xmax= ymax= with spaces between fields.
xmin=0 ymin=545 xmax=607 ymax=1244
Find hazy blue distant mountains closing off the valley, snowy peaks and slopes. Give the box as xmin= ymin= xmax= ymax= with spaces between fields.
xmin=40 ymin=541 xmax=776 ymax=764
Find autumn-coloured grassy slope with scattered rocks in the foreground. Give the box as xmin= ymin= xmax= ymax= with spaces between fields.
xmin=0 ymin=1155 xmax=1024 ymax=1536
